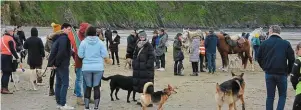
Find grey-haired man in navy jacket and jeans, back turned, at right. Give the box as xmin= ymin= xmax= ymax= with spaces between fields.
xmin=257 ymin=25 xmax=295 ymax=110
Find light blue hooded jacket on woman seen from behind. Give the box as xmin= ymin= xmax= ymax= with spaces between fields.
xmin=78 ymin=36 xmax=108 ymax=71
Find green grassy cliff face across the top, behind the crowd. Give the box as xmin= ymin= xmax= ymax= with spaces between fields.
xmin=1 ymin=1 xmax=301 ymax=28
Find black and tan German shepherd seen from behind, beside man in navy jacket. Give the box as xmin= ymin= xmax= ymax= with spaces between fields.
xmin=215 ymin=72 xmax=245 ymax=110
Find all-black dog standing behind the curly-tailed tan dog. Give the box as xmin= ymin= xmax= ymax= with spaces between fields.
xmin=102 ymin=75 xmax=137 ymax=103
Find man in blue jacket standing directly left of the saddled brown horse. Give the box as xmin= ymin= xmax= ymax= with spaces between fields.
xmin=205 ymin=29 xmax=218 ymax=74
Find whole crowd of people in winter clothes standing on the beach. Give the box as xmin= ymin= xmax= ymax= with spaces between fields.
xmin=1 ymin=23 xmax=301 ymax=110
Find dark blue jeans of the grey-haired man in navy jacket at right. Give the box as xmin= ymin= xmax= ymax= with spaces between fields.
xmin=265 ymin=72 xmax=287 ymax=110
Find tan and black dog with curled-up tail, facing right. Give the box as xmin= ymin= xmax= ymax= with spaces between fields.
xmin=140 ymin=82 xmax=177 ymax=110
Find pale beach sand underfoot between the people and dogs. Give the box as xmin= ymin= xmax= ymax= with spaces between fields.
xmin=1 ymin=46 xmax=295 ymax=110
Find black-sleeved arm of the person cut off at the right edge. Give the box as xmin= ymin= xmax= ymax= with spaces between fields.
xmin=290 ymin=59 xmax=301 ymax=90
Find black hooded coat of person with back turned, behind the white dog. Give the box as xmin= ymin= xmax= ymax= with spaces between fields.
xmin=23 ymin=36 xmax=45 ymax=66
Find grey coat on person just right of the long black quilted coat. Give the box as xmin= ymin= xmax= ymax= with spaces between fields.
xmin=155 ymin=34 xmax=168 ymax=56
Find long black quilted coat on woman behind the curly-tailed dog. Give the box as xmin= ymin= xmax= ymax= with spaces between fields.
xmin=133 ymin=42 xmax=155 ymax=93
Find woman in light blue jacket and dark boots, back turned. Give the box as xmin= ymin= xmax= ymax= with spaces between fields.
xmin=78 ymin=26 xmax=112 ymax=110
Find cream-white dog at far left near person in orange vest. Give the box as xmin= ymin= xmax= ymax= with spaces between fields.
xmin=12 ymin=69 xmax=42 ymax=91
